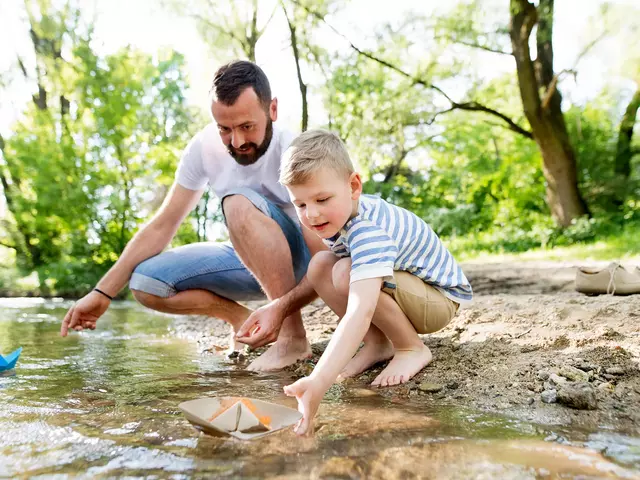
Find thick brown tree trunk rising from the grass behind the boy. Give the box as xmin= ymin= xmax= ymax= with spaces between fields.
xmin=509 ymin=0 xmax=588 ymax=227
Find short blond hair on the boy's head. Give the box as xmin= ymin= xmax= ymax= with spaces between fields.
xmin=280 ymin=129 xmax=354 ymax=186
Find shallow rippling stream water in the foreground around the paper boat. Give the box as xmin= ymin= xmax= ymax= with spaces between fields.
xmin=0 ymin=299 xmax=640 ymax=479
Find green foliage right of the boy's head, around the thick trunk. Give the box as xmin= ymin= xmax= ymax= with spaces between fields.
xmin=327 ymin=49 xmax=639 ymax=252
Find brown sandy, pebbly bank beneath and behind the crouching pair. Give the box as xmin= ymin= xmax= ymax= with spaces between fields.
xmin=175 ymin=261 xmax=640 ymax=435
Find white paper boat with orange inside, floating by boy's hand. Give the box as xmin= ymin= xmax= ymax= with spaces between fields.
xmin=178 ymin=397 xmax=302 ymax=440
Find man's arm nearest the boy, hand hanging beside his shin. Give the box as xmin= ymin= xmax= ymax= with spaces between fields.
xmin=236 ymin=226 xmax=327 ymax=348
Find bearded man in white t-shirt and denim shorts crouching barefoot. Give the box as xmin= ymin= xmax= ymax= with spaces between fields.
xmin=61 ymin=61 xmax=324 ymax=371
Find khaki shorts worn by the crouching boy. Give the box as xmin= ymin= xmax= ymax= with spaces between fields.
xmin=382 ymin=271 xmax=460 ymax=333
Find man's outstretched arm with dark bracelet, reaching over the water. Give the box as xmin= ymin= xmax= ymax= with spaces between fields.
xmin=60 ymin=183 xmax=203 ymax=337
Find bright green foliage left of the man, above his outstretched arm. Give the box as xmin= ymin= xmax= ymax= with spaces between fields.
xmin=0 ymin=4 xmax=202 ymax=295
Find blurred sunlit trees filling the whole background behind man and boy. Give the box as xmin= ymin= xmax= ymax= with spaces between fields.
xmin=0 ymin=0 xmax=640 ymax=295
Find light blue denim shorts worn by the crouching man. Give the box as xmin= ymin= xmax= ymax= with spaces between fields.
xmin=129 ymin=188 xmax=311 ymax=301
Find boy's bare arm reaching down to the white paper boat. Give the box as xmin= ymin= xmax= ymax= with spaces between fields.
xmin=284 ymin=278 xmax=382 ymax=435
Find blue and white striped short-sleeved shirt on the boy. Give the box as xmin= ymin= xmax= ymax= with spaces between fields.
xmin=324 ymin=195 xmax=473 ymax=304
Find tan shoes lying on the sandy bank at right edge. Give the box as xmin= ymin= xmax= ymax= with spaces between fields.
xmin=576 ymin=262 xmax=640 ymax=295
